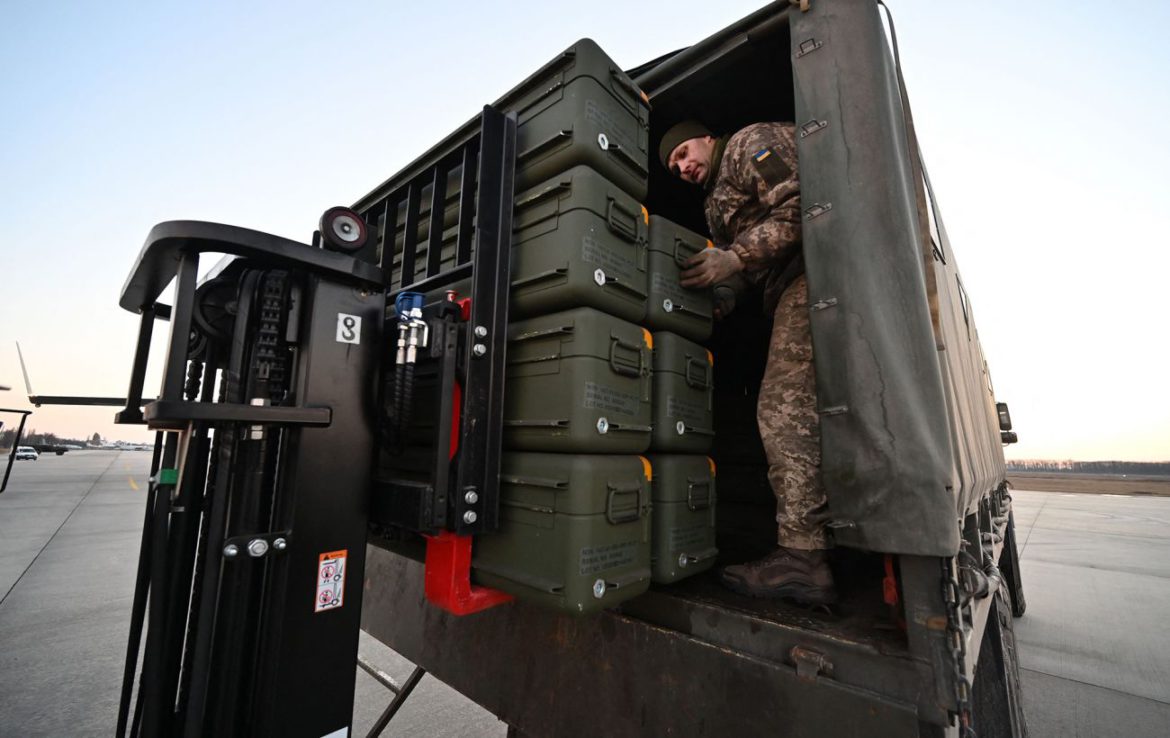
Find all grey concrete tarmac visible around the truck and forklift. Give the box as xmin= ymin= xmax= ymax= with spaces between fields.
xmin=0 ymin=450 xmax=1170 ymax=738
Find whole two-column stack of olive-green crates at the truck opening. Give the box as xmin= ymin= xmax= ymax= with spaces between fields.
xmin=381 ymin=40 xmax=715 ymax=613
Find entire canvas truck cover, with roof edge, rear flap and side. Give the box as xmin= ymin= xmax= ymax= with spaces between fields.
xmin=633 ymin=0 xmax=1004 ymax=557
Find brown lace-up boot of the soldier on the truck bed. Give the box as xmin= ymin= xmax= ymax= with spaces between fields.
xmin=720 ymin=546 xmax=837 ymax=605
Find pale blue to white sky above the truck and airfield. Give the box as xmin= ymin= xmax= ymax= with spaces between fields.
xmin=0 ymin=0 xmax=1170 ymax=461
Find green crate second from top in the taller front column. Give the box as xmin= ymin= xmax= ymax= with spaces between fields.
xmin=510 ymin=166 xmax=647 ymax=323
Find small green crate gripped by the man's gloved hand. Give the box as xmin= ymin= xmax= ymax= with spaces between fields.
xmin=645 ymin=215 xmax=711 ymax=340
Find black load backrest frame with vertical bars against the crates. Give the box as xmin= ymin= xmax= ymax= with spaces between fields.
xmin=363 ymin=106 xmax=516 ymax=534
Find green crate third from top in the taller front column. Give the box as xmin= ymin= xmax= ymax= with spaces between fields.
xmin=504 ymin=308 xmax=652 ymax=454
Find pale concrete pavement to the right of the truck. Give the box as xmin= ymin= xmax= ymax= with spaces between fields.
xmin=1014 ymin=491 xmax=1170 ymax=738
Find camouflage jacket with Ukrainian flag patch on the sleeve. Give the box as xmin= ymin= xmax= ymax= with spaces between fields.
xmin=704 ymin=123 xmax=801 ymax=312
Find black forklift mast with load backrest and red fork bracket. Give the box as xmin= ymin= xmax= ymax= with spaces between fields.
xmin=117 ymin=108 xmax=516 ymax=738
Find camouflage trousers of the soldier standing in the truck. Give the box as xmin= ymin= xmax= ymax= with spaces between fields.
xmin=756 ymin=275 xmax=828 ymax=551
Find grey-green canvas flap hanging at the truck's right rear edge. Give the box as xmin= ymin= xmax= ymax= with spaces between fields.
xmin=790 ymin=0 xmax=959 ymax=556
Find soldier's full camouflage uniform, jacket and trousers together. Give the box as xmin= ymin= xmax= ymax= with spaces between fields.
xmin=704 ymin=123 xmax=828 ymax=551
